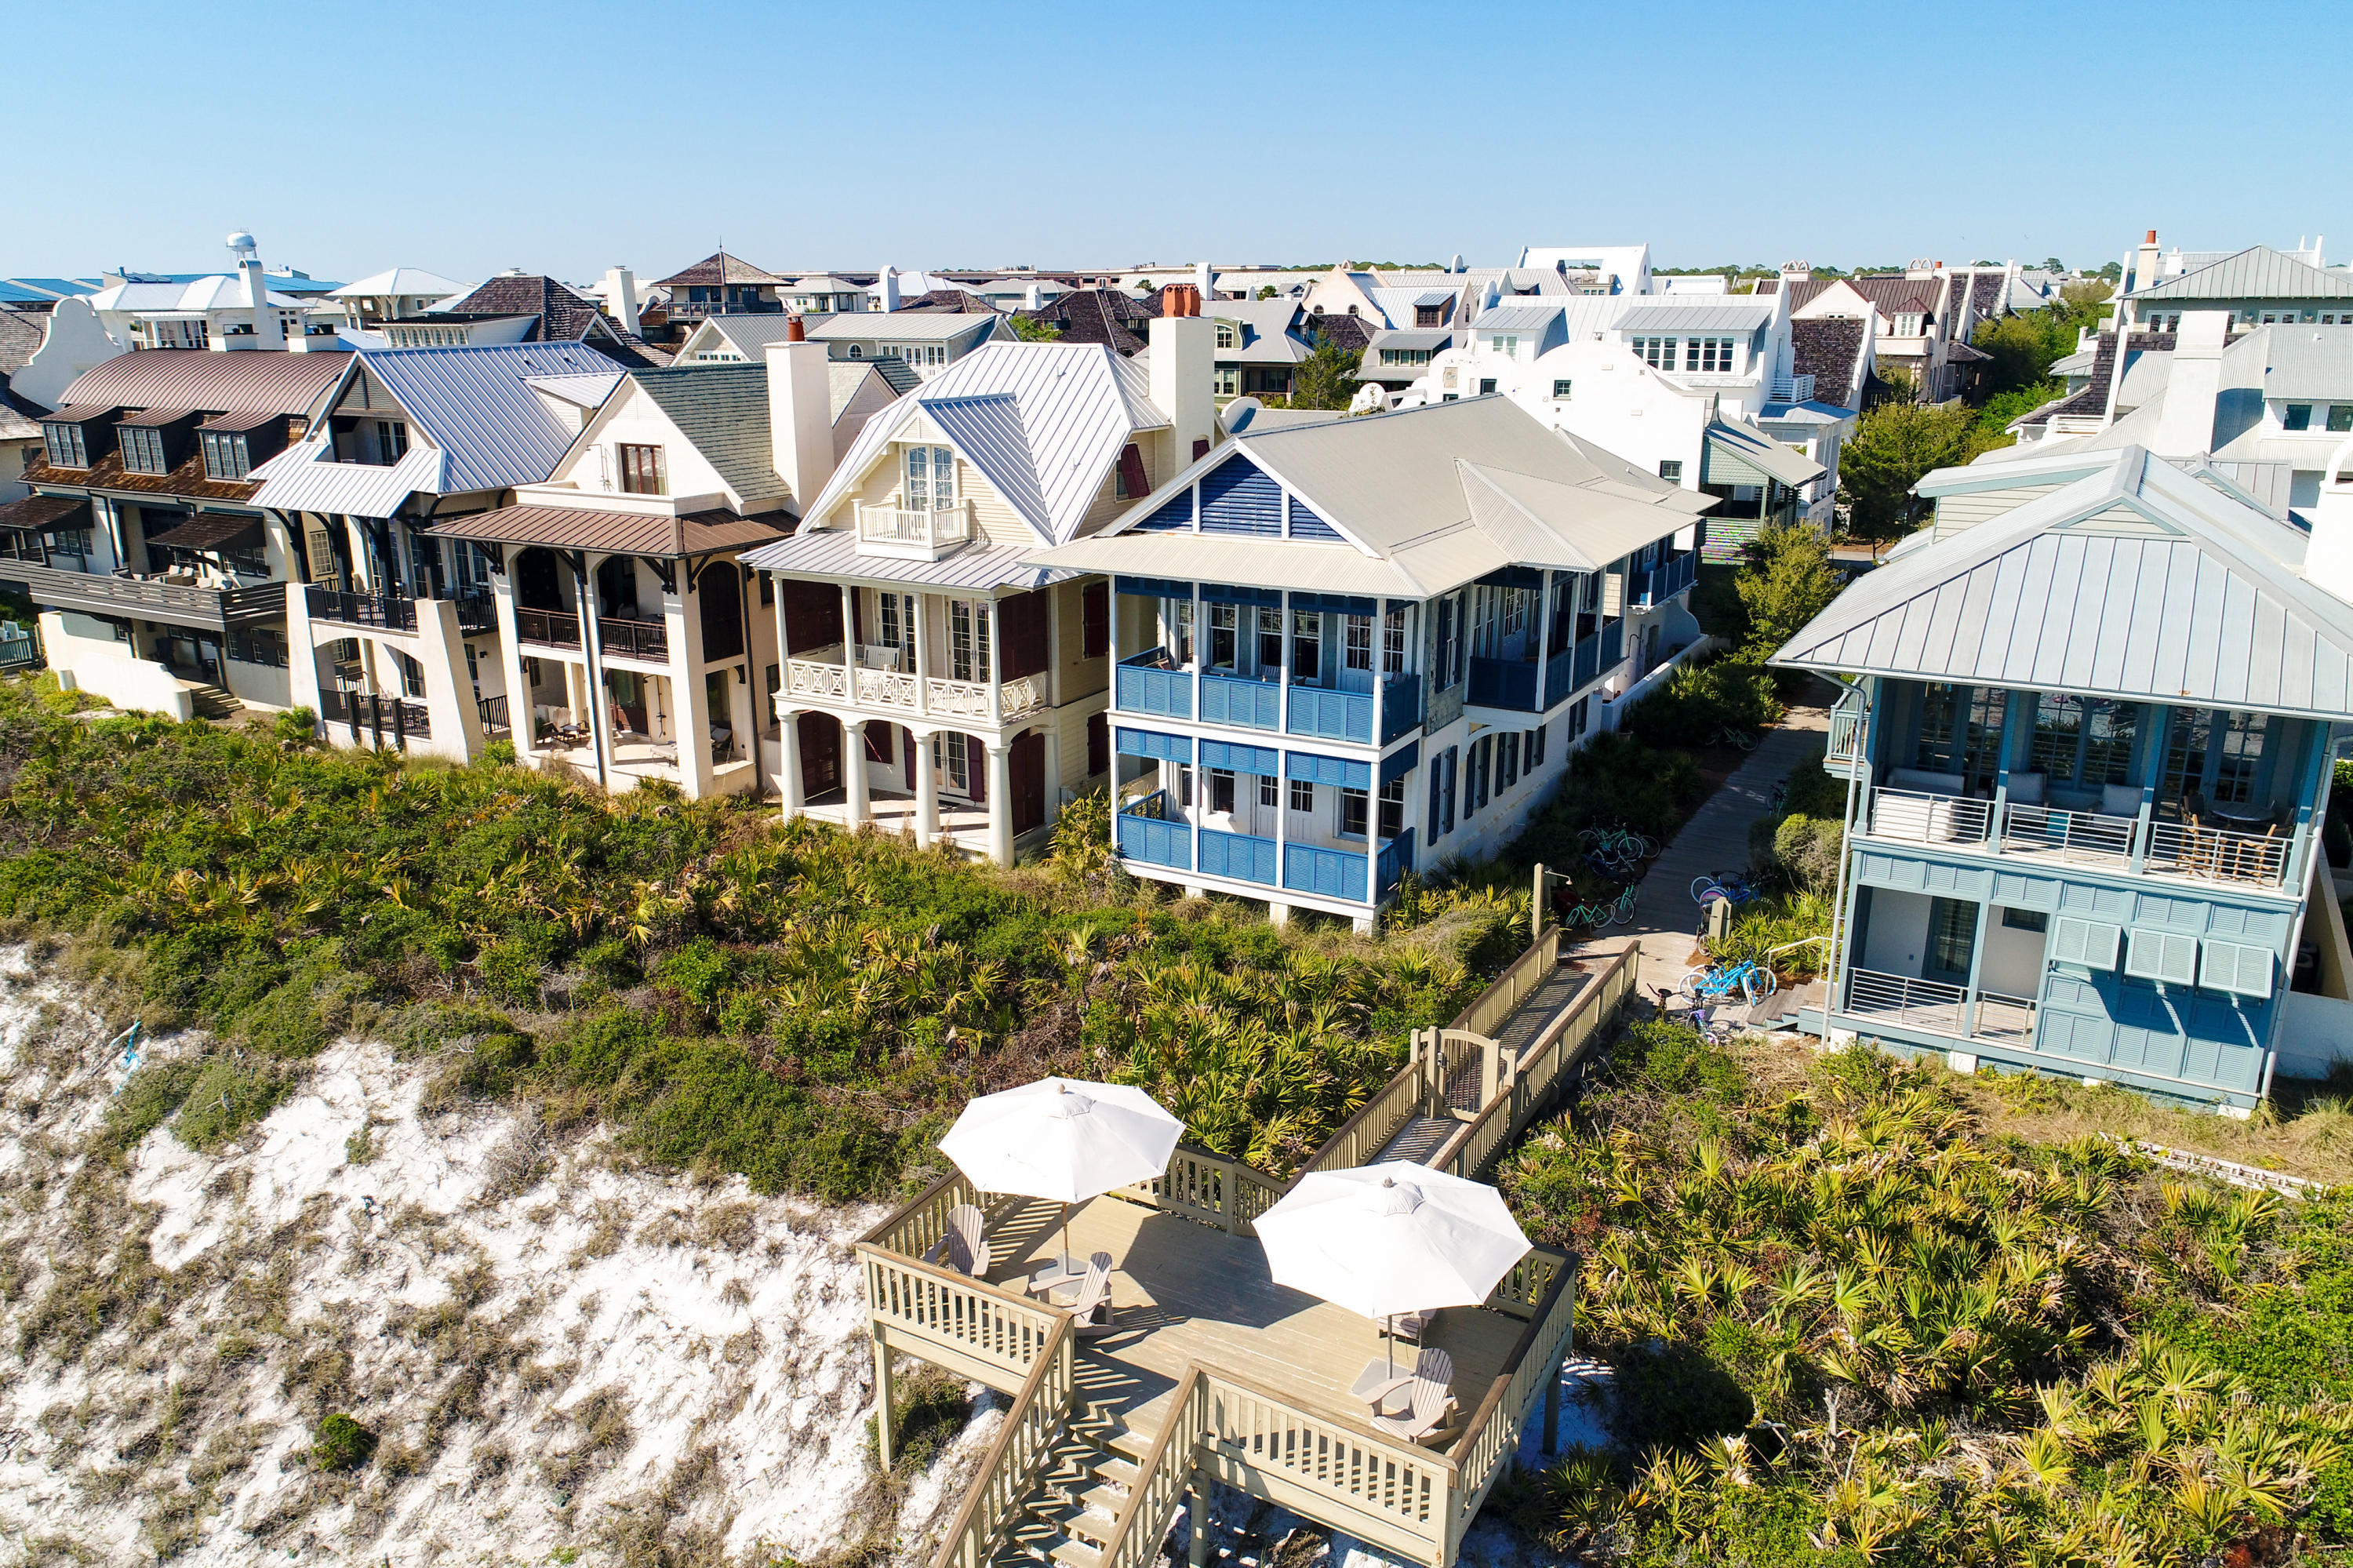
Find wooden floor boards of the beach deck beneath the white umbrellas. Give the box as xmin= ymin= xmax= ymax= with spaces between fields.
xmin=988 ymin=1199 xmax=1525 ymax=1434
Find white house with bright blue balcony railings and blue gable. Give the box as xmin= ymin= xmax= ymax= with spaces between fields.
xmin=1040 ymin=398 xmax=1713 ymax=926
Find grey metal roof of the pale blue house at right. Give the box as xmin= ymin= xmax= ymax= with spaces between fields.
xmin=1774 ymin=447 xmax=2353 ymax=718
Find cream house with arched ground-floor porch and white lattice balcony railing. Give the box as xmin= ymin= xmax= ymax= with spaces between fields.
xmin=744 ymin=315 xmax=1219 ymax=864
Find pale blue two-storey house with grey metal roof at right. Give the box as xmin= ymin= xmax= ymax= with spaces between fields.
xmin=1777 ymin=447 xmax=2353 ymax=1109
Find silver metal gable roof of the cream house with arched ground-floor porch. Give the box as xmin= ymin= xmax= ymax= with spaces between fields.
xmin=791 ymin=344 xmax=1169 ymax=544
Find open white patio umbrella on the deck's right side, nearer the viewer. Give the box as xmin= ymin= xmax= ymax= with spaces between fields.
xmin=1252 ymin=1161 xmax=1529 ymax=1370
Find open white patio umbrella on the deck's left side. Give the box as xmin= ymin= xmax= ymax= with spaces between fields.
xmin=939 ymin=1079 xmax=1184 ymax=1267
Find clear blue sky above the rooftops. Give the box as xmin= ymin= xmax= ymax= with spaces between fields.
xmin=0 ymin=0 xmax=2353 ymax=280
